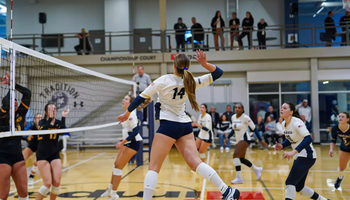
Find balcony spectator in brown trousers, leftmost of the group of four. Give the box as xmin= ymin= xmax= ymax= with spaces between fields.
xmin=211 ymin=11 xmax=225 ymax=51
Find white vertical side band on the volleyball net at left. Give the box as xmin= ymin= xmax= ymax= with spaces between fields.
xmin=10 ymin=47 xmax=16 ymax=135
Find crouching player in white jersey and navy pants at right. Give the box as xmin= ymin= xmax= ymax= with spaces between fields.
xmin=275 ymin=103 xmax=327 ymax=200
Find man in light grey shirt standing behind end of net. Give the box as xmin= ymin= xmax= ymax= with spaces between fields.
xmin=132 ymin=66 xmax=152 ymax=124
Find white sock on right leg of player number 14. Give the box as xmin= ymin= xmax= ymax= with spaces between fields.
xmin=196 ymin=163 xmax=228 ymax=194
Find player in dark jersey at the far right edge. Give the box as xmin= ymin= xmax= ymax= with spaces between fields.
xmin=329 ymin=112 xmax=350 ymax=189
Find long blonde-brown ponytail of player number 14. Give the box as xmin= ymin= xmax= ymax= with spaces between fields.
xmin=183 ymin=70 xmax=199 ymax=112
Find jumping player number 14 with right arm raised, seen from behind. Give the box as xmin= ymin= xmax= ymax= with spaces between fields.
xmin=117 ymin=50 xmax=240 ymax=200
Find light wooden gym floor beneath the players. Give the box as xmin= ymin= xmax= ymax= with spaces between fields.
xmin=9 ymin=146 xmax=350 ymax=200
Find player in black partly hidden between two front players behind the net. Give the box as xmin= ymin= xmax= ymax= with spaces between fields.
xmin=23 ymin=113 xmax=43 ymax=185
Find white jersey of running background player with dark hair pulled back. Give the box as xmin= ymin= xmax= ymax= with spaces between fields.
xmin=231 ymin=113 xmax=255 ymax=142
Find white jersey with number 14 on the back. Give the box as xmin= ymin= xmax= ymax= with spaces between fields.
xmin=141 ymin=74 xmax=213 ymax=123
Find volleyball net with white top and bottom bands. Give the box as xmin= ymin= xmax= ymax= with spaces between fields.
xmin=0 ymin=38 xmax=136 ymax=138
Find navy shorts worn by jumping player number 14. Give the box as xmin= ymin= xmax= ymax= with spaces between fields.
xmin=157 ymin=120 xmax=193 ymax=140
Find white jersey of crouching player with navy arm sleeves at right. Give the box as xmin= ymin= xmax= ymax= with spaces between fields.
xmin=282 ymin=117 xmax=316 ymax=159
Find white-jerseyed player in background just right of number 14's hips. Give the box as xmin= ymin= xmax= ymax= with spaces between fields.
xmin=192 ymin=104 xmax=213 ymax=162
